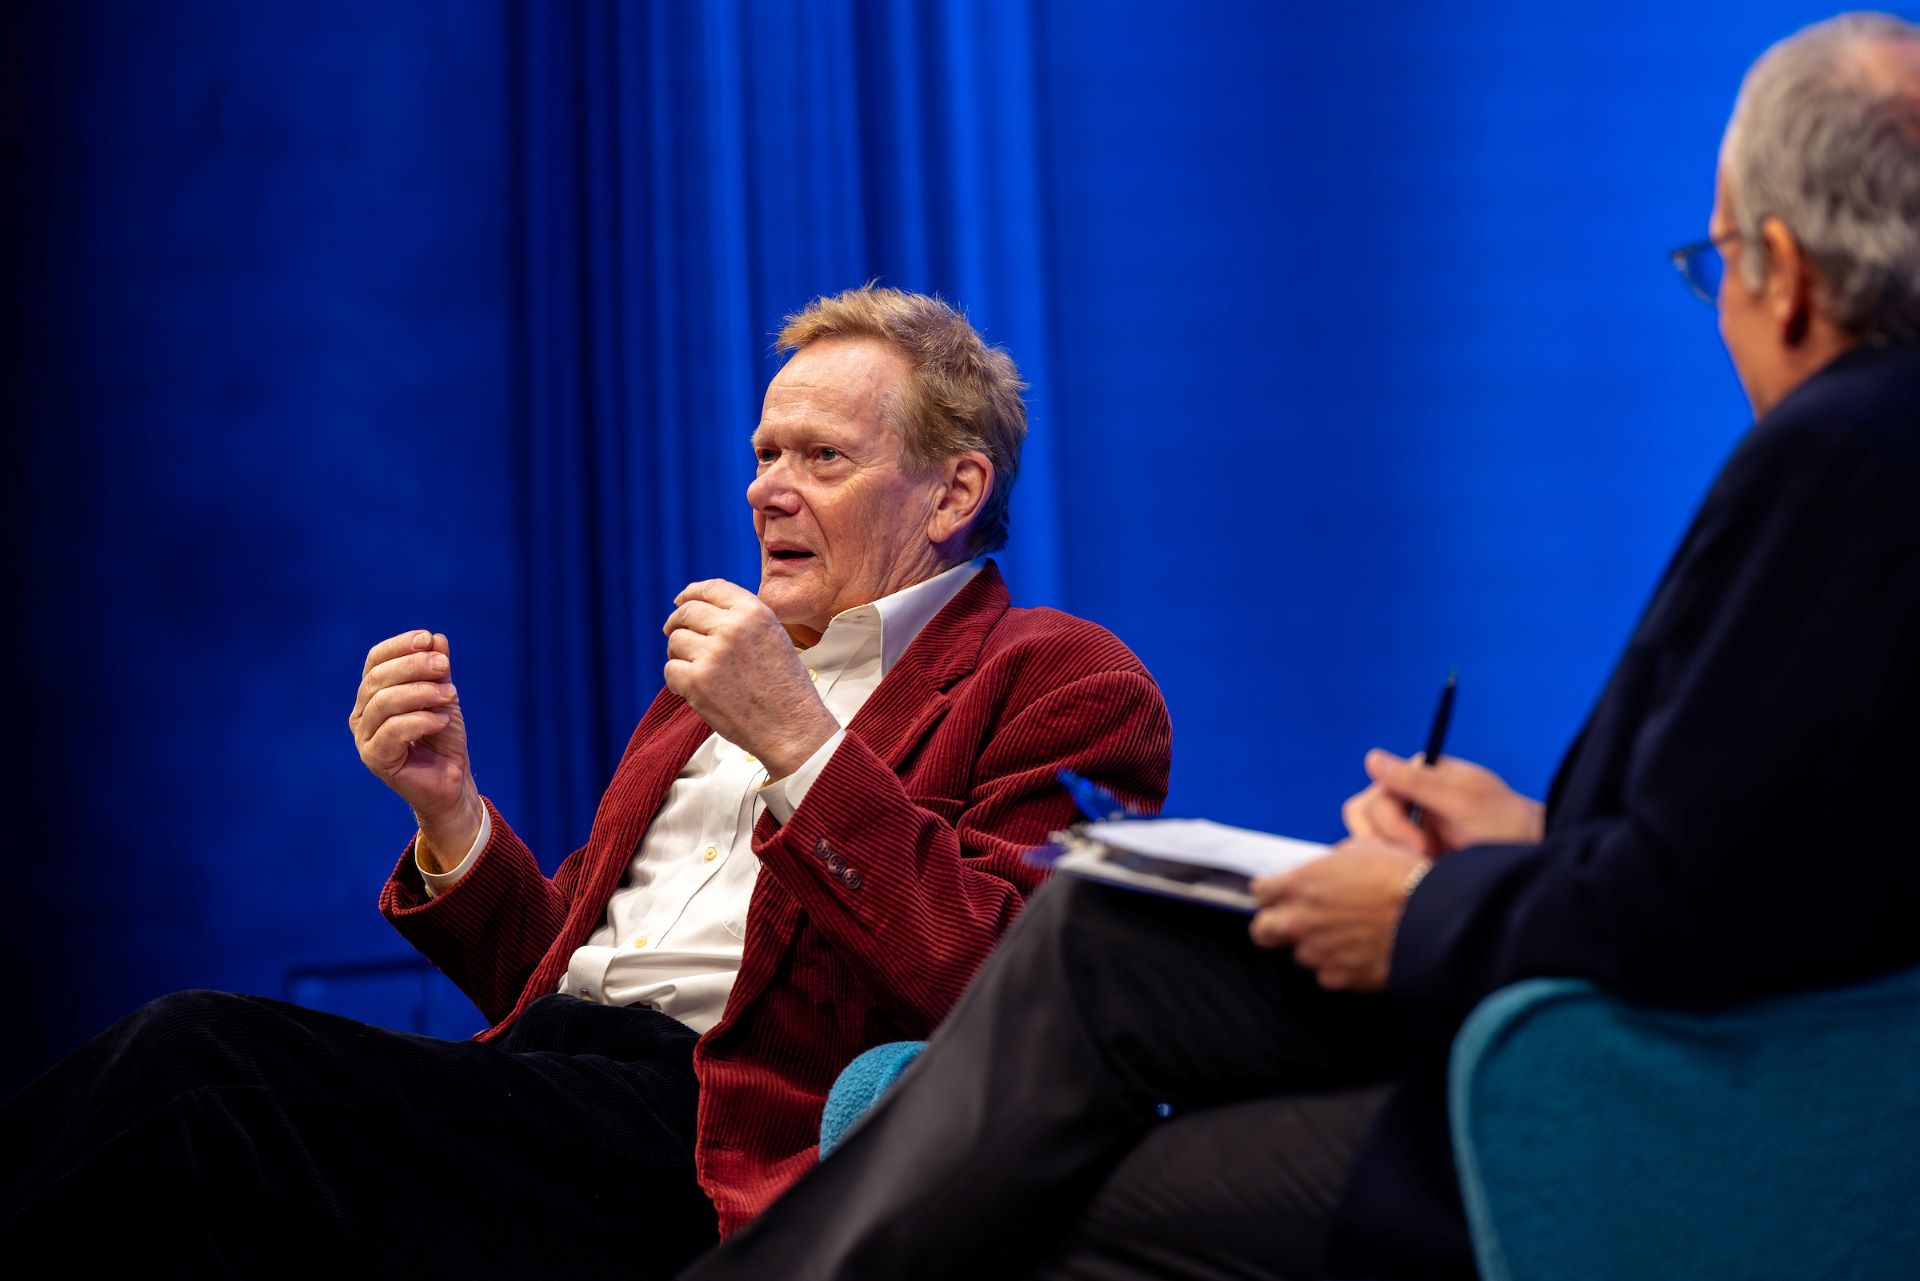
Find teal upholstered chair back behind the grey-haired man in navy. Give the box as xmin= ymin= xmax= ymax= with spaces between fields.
xmin=1450 ymin=971 xmax=1920 ymax=1281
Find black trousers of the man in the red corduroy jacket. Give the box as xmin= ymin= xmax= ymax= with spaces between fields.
xmin=0 ymin=991 xmax=716 ymax=1279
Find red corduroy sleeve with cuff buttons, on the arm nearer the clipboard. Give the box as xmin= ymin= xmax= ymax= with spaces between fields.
xmin=755 ymin=670 xmax=1173 ymax=1033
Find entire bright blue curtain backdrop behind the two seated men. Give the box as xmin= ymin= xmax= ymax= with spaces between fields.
xmin=0 ymin=0 xmax=1850 ymax=1089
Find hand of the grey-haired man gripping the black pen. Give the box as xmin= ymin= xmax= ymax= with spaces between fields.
xmin=1340 ymin=749 xmax=1546 ymax=858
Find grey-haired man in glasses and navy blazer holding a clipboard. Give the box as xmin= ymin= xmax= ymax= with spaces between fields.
xmin=689 ymin=15 xmax=1920 ymax=1281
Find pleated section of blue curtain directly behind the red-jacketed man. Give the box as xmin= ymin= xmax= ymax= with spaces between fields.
xmin=509 ymin=0 xmax=1062 ymax=866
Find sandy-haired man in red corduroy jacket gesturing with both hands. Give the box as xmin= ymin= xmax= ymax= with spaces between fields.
xmin=0 ymin=288 xmax=1171 ymax=1277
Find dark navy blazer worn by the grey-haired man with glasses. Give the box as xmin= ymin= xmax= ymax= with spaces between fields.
xmin=1334 ymin=344 xmax=1920 ymax=1275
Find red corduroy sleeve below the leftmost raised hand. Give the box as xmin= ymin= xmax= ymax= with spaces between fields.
xmin=380 ymin=801 xmax=586 ymax=1024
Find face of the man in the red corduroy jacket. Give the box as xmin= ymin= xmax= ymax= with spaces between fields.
xmin=747 ymin=338 xmax=943 ymax=643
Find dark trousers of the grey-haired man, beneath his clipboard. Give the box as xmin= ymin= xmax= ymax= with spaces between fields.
xmin=685 ymin=878 xmax=1409 ymax=1281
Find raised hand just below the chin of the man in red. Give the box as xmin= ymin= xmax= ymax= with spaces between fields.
xmin=660 ymin=578 xmax=839 ymax=778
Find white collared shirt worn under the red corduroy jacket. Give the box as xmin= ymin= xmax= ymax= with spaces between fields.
xmin=420 ymin=561 xmax=979 ymax=1033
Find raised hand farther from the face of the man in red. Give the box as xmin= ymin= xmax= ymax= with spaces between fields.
xmin=348 ymin=630 xmax=482 ymax=872
